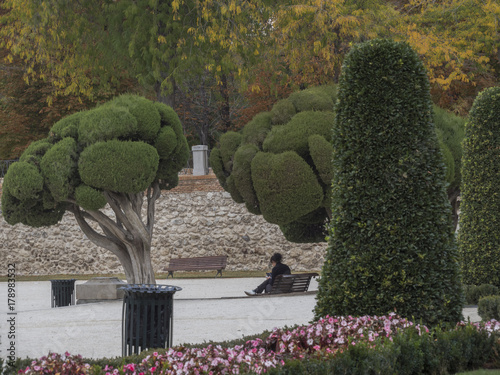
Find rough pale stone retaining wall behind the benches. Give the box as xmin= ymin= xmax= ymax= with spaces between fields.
xmin=0 ymin=175 xmax=326 ymax=275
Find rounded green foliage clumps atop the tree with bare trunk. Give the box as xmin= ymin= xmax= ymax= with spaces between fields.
xmin=2 ymin=95 xmax=189 ymax=226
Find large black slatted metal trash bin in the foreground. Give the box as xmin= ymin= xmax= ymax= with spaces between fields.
xmin=119 ymin=284 xmax=182 ymax=356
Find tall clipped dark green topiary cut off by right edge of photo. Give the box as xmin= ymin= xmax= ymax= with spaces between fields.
xmin=458 ymin=87 xmax=500 ymax=287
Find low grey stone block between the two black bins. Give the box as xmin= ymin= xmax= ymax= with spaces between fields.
xmin=76 ymin=277 xmax=127 ymax=305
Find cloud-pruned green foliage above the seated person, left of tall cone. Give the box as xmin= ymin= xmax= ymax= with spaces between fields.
xmin=210 ymin=86 xmax=336 ymax=242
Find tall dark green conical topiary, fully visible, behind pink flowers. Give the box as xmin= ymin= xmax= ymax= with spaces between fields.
xmin=315 ymin=40 xmax=462 ymax=325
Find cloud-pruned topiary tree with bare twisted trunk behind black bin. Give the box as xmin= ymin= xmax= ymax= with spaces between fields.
xmin=2 ymin=95 xmax=189 ymax=284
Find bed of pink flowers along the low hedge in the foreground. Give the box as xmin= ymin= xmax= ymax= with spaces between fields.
xmin=20 ymin=314 xmax=500 ymax=375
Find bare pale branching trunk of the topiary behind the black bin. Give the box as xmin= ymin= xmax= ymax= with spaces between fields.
xmin=69 ymin=183 xmax=160 ymax=284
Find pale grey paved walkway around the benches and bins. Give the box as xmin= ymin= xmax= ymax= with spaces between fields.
xmin=0 ymin=278 xmax=480 ymax=358
